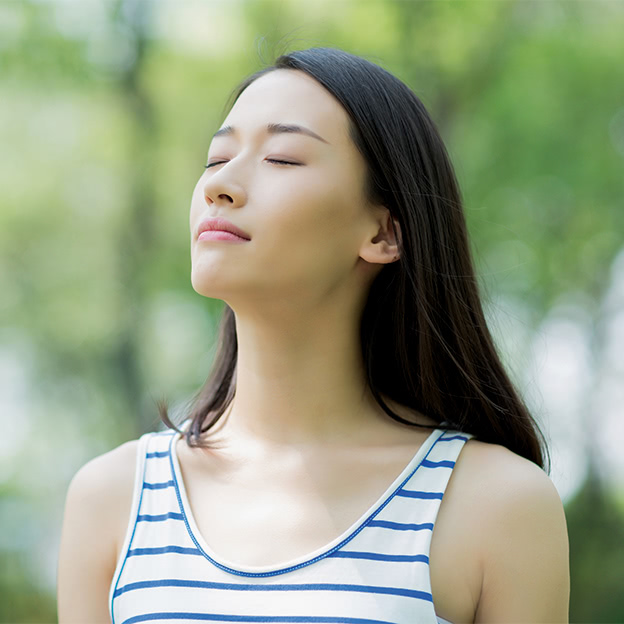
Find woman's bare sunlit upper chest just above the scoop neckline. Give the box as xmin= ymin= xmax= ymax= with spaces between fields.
xmin=181 ymin=446 xmax=416 ymax=566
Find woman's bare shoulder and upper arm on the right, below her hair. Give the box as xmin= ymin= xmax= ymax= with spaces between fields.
xmin=432 ymin=440 xmax=569 ymax=622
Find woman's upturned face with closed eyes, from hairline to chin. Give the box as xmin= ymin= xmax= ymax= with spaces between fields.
xmin=190 ymin=70 xmax=381 ymax=308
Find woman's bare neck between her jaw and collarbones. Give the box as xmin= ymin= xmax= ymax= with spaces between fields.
xmin=214 ymin=292 xmax=387 ymax=448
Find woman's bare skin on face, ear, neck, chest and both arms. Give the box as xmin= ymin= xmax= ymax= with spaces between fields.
xmin=58 ymin=70 xmax=569 ymax=624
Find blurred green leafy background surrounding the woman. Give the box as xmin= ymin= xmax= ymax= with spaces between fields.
xmin=0 ymin=0 xmax=624 ymax=623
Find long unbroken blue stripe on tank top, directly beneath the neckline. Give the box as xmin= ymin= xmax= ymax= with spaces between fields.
xmin=115 ymin=579 xmax=433 ymax=602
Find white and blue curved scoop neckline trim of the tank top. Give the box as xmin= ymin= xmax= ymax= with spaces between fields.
xmin=169 ymin=429 xmax=444 ymax=576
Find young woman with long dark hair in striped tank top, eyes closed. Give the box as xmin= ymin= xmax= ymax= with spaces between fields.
xmin=58 ymin=48 xmax=569 ymax=624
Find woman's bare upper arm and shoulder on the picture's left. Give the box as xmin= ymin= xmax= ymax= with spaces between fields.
xmin=57 ymin=441 xmax=138 ymax=624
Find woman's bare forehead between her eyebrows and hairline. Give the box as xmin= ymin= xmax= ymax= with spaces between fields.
xmin=223 ymin=69 xmax=350 ymax=145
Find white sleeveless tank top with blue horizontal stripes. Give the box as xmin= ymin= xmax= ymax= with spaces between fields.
xmin=109 ymin=429 xmax=472 ymax=624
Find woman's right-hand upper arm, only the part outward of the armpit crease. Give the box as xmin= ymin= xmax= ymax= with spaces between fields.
xmin=475 ymin=447 xmax=570 ymax=623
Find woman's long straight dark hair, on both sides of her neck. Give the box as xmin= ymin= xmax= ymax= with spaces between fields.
xmin=158 ymin=47 xmax=548 ymax=467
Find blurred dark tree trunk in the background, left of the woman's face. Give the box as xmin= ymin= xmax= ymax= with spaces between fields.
xmin=108 ymin=0 xmax=159 ymax=433
